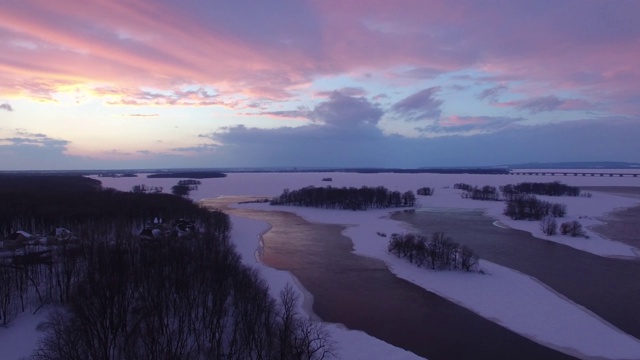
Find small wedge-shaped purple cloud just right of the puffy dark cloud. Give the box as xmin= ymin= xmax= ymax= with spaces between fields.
xmin=391 ymin=86 xmax=443 ymax=121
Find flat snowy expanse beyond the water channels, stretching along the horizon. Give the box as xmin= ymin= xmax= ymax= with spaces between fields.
xmin=93 ymin=170 xmax=640 ymax=257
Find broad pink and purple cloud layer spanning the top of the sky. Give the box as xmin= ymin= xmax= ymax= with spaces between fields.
xmin=0 ymin=0 xmax=640 ymax=113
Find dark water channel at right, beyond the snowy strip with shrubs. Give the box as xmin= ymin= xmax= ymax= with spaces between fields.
xmin=392 ymin=209 xmax=640 ymax=338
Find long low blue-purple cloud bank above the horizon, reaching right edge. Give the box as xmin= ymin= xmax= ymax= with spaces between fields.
xmin=203 ymin=117 xmax=640 ymax=167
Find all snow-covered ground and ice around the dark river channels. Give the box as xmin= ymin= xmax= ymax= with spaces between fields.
xmin=0 ymin=173 xmax=640 ymax=359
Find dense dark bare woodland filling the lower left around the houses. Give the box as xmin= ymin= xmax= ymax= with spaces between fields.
xmin=0 ymin=176 xmax=331 ymax=360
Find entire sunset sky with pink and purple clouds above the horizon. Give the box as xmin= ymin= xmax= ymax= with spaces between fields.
xmin=0 ymin=0 xmax=640 ymax=170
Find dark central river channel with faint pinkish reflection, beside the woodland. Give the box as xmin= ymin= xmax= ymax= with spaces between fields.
xmin=204 ymin=200 xmax=572 ymax=360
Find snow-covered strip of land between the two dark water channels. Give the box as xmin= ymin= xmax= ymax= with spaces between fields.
xmin=224 ymin=200 xmax=640 ymax=359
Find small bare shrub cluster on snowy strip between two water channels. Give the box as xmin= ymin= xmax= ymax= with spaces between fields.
xmin=388 ymin=232 xmax=478 ymax=271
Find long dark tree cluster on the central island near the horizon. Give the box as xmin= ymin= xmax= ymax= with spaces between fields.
xmin=271 ymin=186 xmax=416 ymax=210
